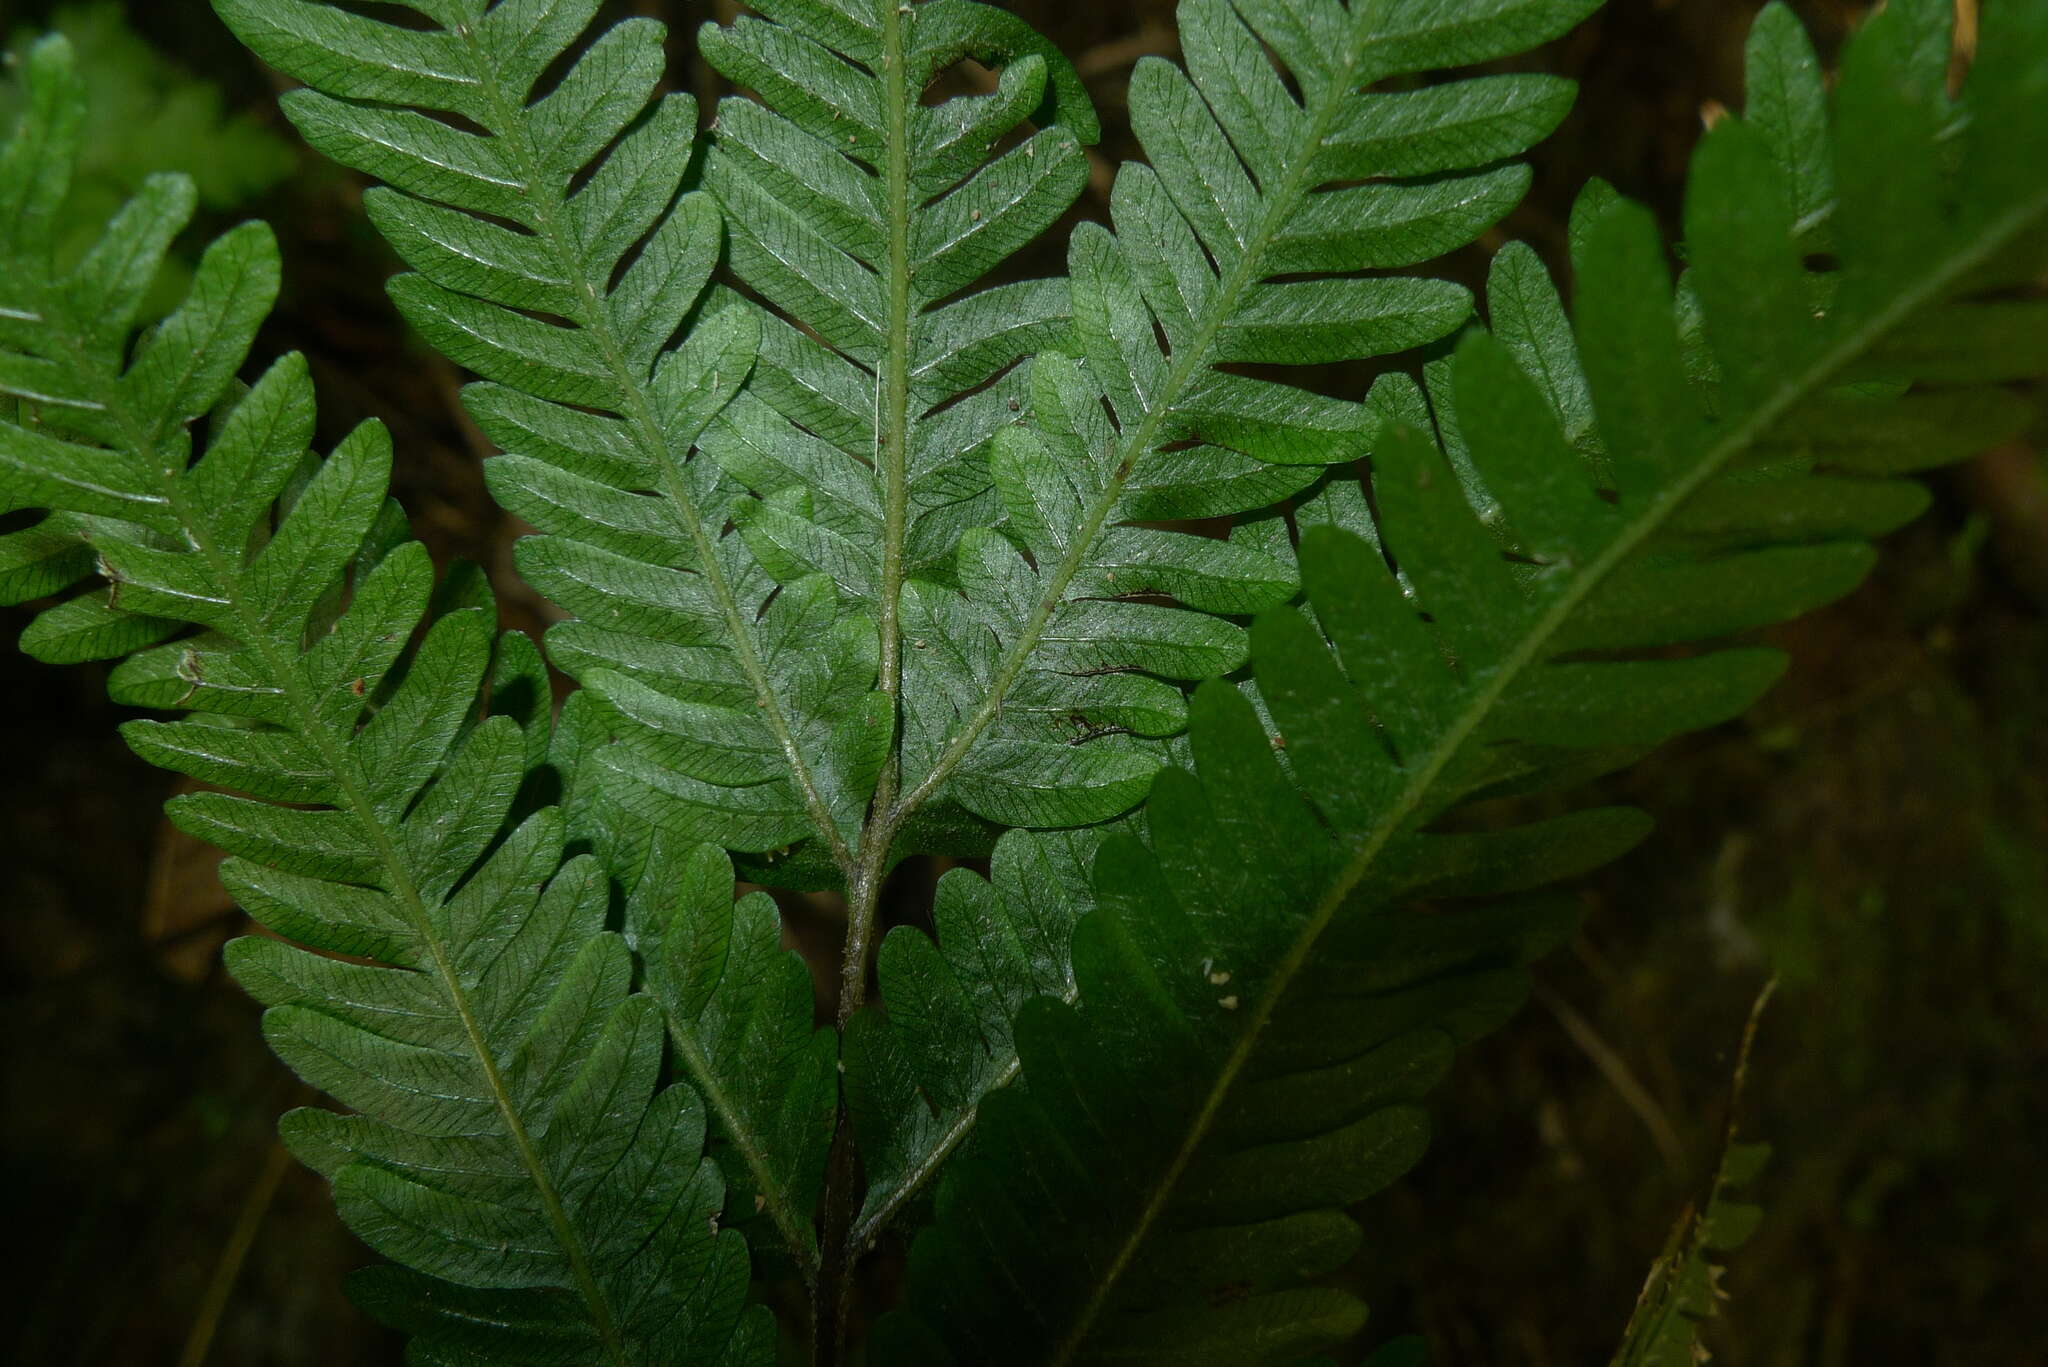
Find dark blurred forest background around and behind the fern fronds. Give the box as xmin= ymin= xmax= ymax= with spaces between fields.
xmin=0 ymin=0 xmax=2048 ymax=1367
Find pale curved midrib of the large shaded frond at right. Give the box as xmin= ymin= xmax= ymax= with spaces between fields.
xmin=1049 ymin=166 xmax=2048 ymax=1367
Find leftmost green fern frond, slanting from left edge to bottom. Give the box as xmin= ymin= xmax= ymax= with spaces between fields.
xmin=0 ymin=39 xmax=772 ymax=1367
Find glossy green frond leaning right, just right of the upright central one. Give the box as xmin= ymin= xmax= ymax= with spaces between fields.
xmin=872 ymin=0 xmax=1593 ymax=826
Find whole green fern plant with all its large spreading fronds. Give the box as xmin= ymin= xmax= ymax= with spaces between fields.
xmin=0 ymin=0 xmax=2048 ymax=1367
